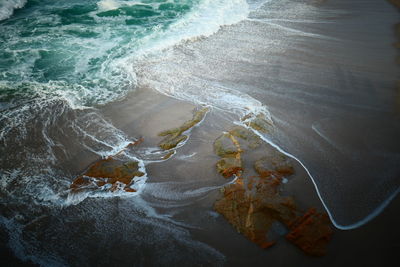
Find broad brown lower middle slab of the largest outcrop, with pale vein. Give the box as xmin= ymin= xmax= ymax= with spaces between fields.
xmin=214 ymin=177 xmax=296 ymax=248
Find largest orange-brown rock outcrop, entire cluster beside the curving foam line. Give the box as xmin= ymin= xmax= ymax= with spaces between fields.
xmin=214 ymin=126 xmax=332 ymax=256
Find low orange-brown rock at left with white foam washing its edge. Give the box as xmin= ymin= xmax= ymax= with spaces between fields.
xmin=70 ymin=157 xmax=144 ymax=192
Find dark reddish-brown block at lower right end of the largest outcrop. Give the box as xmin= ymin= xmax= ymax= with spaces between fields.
xmin=286 ymin=208 xmax=332 ymax=256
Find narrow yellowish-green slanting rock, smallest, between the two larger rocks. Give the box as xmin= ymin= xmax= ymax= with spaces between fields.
xmin=158 ymin=108 xmax=209 ymax=150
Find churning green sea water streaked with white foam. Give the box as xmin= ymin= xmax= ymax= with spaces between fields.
xmin=0 ymin=0 xmax=199 ymax=105
